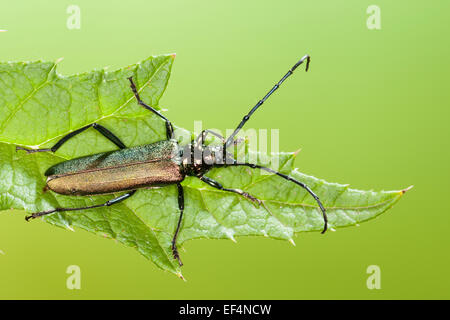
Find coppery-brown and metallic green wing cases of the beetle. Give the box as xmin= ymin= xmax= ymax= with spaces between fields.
xmin=45 ymin=140 xmax=184 ymax=196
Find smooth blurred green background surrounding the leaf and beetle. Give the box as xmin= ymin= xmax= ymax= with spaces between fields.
xmin=0 ymin=0 xmax=450 ymax=299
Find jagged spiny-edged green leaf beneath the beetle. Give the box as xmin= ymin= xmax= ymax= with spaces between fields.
xmin=0 ymin=55 xmax=406 ymax=277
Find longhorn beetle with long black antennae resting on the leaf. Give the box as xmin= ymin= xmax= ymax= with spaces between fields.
xmin=16 ymin=55 xmax=327 ymax=266
